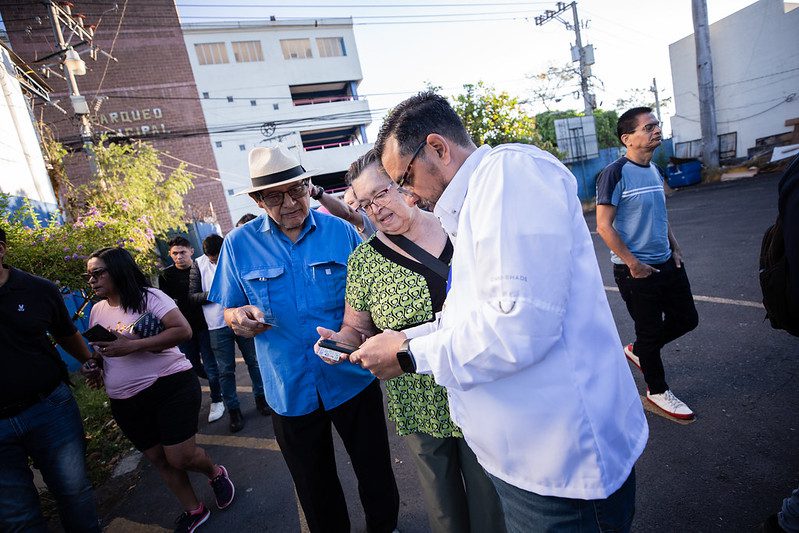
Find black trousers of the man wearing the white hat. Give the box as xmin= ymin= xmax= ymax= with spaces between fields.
xmin=272 ymin=380 xmax=399 ymax=533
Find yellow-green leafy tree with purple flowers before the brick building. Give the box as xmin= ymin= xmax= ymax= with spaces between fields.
xmin=0 ymin=136 xmax=193 ymax=290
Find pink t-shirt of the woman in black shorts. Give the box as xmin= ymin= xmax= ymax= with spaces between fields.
xmin=89 ymin=289 xmax=191 ymax=400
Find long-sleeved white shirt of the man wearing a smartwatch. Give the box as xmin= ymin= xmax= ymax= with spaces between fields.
xmin=406 ymin=144 xmax=649 ymax=499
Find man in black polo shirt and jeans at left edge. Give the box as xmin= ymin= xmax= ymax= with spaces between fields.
xmin=0 ymin=229 xmax=100 ymax=532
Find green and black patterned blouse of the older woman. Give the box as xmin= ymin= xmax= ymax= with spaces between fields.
xmin=347 ymin=237 xmax=463 ymax=438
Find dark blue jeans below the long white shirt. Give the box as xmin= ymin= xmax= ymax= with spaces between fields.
xmin=488 ymin=469 xmax=635 ymax=533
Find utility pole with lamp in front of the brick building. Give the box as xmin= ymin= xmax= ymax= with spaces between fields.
xmin=48 ymin=0 xmax=98 ymax=176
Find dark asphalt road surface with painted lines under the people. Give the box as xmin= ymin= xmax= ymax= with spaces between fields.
xmin=97 ymin=172 xmax=799 ymax=533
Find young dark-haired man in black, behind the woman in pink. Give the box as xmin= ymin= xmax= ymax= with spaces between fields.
xmin=158 ymin=236 xmax=225 ymax=422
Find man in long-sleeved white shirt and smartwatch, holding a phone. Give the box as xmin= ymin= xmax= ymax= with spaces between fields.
xmin=350 ymin=93 xmax=648 ymax=532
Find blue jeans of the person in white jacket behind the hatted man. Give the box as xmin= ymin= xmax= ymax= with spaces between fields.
xmin=208 ymin=326 xmax=264 ymax=411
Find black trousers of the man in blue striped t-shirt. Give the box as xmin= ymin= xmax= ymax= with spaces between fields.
xmin=613 ymin=259 xmax=699 ymax=394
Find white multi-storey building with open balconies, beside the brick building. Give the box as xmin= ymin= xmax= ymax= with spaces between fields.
xmin=182 ymin=18 xmax=371 ymax=222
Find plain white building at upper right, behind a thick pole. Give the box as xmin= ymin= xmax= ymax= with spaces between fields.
xmin=669 ymin=0 xmax=799 ymax=160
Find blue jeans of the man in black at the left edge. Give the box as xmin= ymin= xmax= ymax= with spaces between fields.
xmin=0 ymin=383 xmax=100 ymax=532
